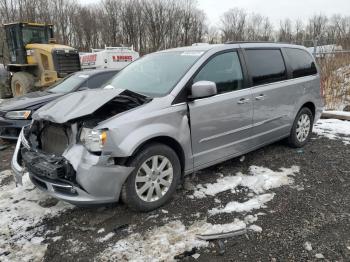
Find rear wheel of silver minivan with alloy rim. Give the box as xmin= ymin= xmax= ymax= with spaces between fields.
xmin=288 ymin=107 xmax=314 ymax=148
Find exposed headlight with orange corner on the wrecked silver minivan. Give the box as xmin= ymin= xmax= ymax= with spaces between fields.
xmin=80 ymin=127 xmax=107 ymax=152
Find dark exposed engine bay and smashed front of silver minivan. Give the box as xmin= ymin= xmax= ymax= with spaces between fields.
xmin=21 ymin=90 xmax=150 ymax=185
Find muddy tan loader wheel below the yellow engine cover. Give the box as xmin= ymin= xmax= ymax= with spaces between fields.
xmin=11 ymin=72 xmax=34 ymax=97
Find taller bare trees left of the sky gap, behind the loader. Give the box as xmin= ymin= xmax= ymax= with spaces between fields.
xmin=0 ymin=0 xmax=205 ymax=53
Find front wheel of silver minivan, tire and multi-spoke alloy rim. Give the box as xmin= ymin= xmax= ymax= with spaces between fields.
xmin=121 ymin=143 xmax=181 ymax=212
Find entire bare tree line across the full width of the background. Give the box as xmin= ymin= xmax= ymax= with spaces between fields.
xmin=0 ymin=0 xmax=350 ymax=57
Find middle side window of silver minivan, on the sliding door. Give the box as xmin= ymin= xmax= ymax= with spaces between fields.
xmin=245 ymin=49 xmax=287 ymax=86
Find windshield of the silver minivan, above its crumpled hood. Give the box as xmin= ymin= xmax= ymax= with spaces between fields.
xmin=106 ymin=51 xmax=204 ymax=97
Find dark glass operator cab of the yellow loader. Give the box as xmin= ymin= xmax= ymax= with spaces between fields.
xmin=4 ymin=23 xmax=53 ymax=64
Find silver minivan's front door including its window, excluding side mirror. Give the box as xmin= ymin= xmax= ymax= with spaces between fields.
xmin=189 ymin=51 xmax=253 ymax=168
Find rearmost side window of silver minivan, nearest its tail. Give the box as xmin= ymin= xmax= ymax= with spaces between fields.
xmin=285 ymin=48 xmax=317 ymax=78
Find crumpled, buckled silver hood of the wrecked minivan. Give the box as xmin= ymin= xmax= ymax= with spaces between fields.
xmin=33 ymin=89 xmax=125 ymax=124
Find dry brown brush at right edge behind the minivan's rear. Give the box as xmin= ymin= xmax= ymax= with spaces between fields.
xmin=317 ymin=53 xmax=350 ymax=110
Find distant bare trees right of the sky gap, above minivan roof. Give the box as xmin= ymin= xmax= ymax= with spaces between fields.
xmin=220 ymin=8 xmax=350 ymax=48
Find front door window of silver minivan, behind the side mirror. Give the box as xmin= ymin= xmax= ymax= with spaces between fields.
xmin=193 ymin=52 xmax=243 ymax=94
